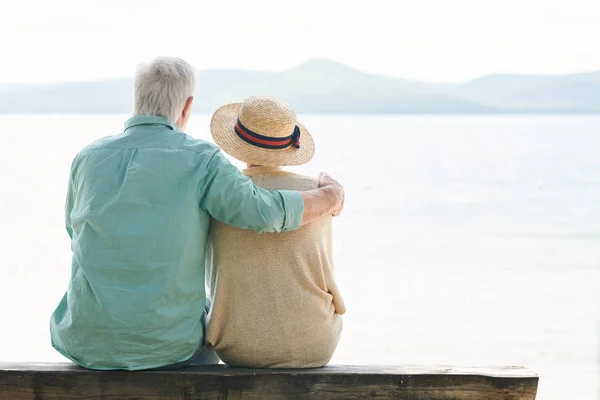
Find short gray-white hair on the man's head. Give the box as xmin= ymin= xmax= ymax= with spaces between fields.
xmin=133 ymin=57 xmax=196 ymax=122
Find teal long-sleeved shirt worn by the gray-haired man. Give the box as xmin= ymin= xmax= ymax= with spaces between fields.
xmin=50 ymin=116 xmax=304 ymax=370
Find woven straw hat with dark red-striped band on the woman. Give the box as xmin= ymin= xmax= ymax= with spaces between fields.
xmin=210 ymin=96 xmax=315 ymax=167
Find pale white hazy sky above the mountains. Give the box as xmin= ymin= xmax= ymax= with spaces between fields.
xmin=0 ymin=0 xmax=600 ymax=82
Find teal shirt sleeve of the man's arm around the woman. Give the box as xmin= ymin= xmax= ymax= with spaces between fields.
xmin=200 ymin=151 xmax=304 ymax=233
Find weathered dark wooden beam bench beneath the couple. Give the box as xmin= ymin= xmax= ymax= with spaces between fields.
xmin=0 ymin=363 xmax=538 ymax=400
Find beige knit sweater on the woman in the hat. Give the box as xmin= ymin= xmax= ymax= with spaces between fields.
xmin=206 ymin=167 xmax=346 ymax=368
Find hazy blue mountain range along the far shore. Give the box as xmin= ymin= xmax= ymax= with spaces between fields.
xmin=0 ymin=59 xmax=600 ymax=114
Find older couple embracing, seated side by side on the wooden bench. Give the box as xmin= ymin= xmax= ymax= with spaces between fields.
xmin=50 ymin=58 xmax=345 ymax=370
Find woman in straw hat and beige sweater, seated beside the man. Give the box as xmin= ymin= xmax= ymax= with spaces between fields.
xmin=206 ymin=97 xmax=346 ymax=368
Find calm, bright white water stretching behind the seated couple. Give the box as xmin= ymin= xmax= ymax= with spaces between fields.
xmin=0 ymin=116 xmax=600 ymax=400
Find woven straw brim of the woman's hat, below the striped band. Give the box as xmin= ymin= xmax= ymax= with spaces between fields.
xmin=210 ymin=103 xmax=315 ymax=167
